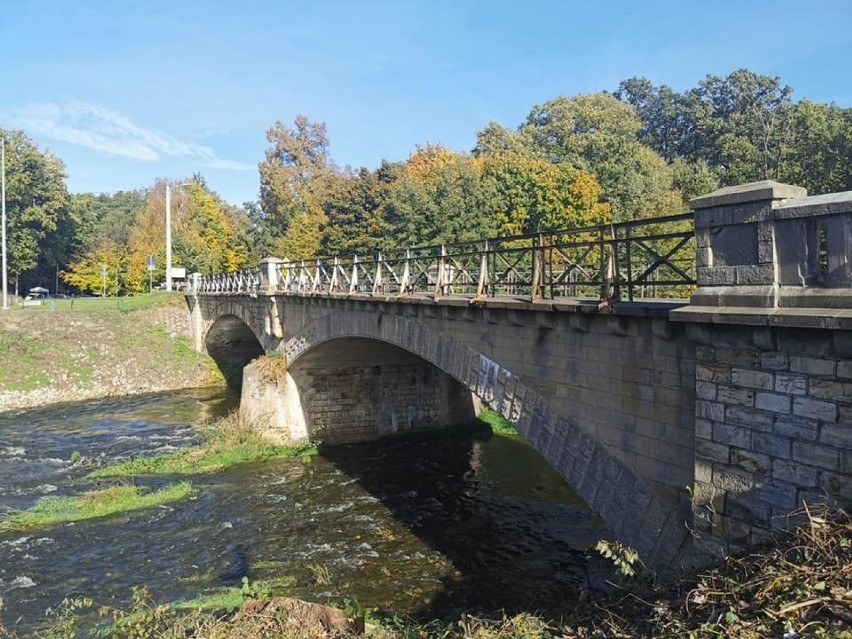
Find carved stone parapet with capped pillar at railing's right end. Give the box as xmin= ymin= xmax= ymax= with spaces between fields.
xmin=690 ymin=180 xmax=852 ymax=309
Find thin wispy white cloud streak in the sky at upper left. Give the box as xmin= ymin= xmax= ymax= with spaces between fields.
xmin=8 ymin=100 xmax=256 ymax=171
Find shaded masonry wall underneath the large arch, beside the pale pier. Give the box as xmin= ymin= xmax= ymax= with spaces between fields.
xmin=293 ymin=362 xmax=476 ymax=444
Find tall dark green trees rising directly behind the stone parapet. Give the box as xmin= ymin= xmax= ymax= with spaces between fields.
xmin=615 ymin=69 xmax=852 ymax=192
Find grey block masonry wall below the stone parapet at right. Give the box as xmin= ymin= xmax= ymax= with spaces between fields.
xmin=688 ymin=325 xmax=852 ymax=554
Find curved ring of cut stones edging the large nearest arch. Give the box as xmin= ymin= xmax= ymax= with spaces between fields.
xmin=278 ymin=311 xmax=689 ymax=565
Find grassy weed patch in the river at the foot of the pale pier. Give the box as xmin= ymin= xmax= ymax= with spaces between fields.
xmin=88 ymin=414 xmax=319 ymax=479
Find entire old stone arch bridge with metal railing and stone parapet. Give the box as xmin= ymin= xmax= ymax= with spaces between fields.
xmin=187 ymin=182 xmax=852 ymax=566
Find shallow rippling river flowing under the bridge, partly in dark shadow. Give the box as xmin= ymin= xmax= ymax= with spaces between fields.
xmin=0 ymin=390 xmax=603 ymax=635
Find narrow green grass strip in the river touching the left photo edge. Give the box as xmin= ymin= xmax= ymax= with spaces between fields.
xmin=0 ymin=482 xmax=192 ymax=530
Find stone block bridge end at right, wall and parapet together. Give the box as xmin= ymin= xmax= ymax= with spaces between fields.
xmin=671 ymin=181 xmax=852 ymax=556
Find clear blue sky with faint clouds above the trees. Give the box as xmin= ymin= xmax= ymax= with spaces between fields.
xmin=0 ymin=0 xmax=852 ymax=203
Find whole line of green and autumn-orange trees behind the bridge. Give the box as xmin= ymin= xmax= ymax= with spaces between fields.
xmin=2 ymin=69 xmax=852 ymax=294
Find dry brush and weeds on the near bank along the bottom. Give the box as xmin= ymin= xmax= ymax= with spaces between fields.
xmin=16 ymin=509 xmax=852 ymax=639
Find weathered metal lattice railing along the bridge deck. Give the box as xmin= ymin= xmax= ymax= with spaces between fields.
xmin=190 ymin=213 xmax=695 ymax=300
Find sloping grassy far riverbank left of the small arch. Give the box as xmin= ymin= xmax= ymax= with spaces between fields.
xmin=0 ymin=293 xmax=223 ymax=411
